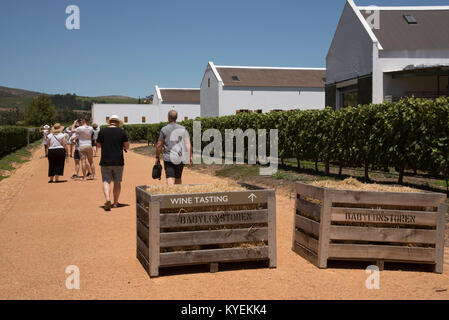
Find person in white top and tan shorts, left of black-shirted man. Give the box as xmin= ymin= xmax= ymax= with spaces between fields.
xmin=72 ymin=118 xmax=95 ymax=181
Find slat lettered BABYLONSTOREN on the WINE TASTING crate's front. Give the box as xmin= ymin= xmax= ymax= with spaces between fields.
xmin=160 ymin=209 xmax=268 ymax=228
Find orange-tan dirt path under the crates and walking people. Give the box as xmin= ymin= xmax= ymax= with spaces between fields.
xmin=0 ymin=145 xmax=449 ymax=299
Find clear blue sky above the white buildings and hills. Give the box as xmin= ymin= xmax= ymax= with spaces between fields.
xmin=0 ymin=0 xmax=449 ymax=97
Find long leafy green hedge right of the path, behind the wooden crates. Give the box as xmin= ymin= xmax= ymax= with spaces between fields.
xmin=111 ymin=97 xmax=449 ymax=183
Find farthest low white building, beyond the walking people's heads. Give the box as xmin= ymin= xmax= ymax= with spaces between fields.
xmin=92 ymin=86 xmax=200 ymax=126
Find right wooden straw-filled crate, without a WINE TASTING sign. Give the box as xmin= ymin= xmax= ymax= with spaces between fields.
xmin=292 ymin=182 xmax=447 ymax=273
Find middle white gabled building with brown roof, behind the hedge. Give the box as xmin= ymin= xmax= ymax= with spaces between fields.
xmin=201 ymin=62 xmax=326 ymax=118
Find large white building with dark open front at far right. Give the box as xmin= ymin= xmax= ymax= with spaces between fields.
xmin=326 ymin=0 xmax=449 ymax=108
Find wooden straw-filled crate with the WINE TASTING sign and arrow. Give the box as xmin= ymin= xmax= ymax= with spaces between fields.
xmin=136 ymin=184 xmax=276 ymax=277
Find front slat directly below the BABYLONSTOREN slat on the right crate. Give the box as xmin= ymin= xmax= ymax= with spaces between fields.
xmin=330 ymin=226 xmax=436 ymax=244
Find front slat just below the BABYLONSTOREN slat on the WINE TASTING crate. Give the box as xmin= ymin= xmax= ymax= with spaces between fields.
xmin=160 ymin=228 xmax=268 ymax=248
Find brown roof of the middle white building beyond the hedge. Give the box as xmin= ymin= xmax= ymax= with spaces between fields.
xmin=216 ymin=66 xmax=326 ymax=88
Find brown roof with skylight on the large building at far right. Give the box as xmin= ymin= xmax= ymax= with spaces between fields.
xmin=347 ymin=0 xmax=449 ymax=50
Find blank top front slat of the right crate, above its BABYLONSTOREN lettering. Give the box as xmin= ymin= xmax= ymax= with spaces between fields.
xmin=326 ymin=189 xmax=446 ymax=207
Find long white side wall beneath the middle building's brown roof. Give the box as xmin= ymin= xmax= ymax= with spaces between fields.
xmin=219 ymin=87 xmax=325 ymax=116
